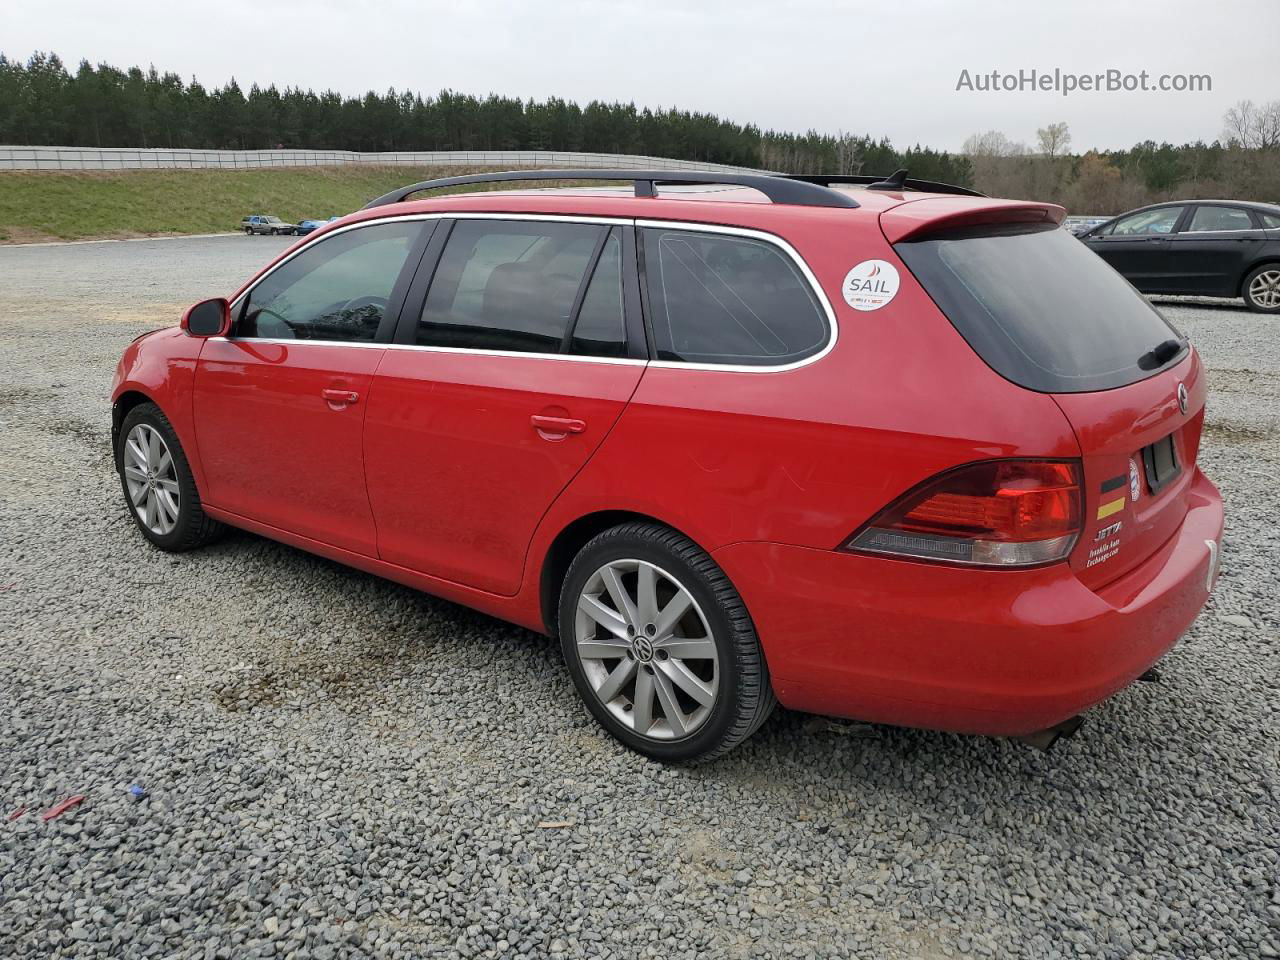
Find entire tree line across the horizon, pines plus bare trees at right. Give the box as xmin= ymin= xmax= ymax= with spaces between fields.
xmin=0 ymin=52 xmax=1280 ymax=214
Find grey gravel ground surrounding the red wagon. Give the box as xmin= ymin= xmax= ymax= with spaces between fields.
xmin=0 ymin=237 xmax=1280 ymax=960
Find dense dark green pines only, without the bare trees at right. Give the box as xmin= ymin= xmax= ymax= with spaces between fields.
xmin=0 ymin=54 xmax=969 ymax=183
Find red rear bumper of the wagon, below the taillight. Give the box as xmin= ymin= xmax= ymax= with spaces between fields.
xmin=714 ymin=470 xmax=1222 ymax=735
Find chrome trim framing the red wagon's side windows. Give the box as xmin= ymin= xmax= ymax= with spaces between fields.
xmin=227 ymin=210 xmax=840 ymax=374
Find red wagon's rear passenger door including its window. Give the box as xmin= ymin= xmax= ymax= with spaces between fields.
xmin=365 ymin=218 xmax=645 ymax=595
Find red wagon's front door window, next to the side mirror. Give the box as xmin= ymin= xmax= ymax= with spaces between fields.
xmin=234 ymin=220 xmax=422 ymax=342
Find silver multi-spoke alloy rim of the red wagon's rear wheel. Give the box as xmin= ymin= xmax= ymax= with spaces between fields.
xmin=573 ymin=559 xmax=719 ymax=740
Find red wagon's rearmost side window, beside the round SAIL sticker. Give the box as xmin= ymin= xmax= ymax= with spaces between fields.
xmin=644 ymin=228 xmax=831 ymax=366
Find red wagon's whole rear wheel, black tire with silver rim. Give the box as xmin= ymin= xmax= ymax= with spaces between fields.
xmin=558 ymin=522 xmax=777 ymax=763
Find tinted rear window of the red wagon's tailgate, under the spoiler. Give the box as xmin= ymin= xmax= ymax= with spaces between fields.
xmin=895 ymin=224 xmax=1183 ymax=393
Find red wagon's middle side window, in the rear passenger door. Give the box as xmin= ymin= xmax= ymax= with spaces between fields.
xmin=415 ymin=219 xmax=626 ymax=356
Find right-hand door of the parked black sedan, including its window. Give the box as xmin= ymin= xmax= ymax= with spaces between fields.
xmin=1169 ymin=204 xmax=1267 ymax=297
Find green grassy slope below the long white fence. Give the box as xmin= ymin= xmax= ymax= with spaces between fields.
xmin=0 ymin=166 xmax=519 ymax=243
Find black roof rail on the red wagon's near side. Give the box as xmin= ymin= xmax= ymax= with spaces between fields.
xmin=365 ymin=169 xmax=860 ymax=210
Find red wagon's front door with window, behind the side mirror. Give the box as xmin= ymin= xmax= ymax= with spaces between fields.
xmin=193 ymin=219 xmax=434 ymax=556
